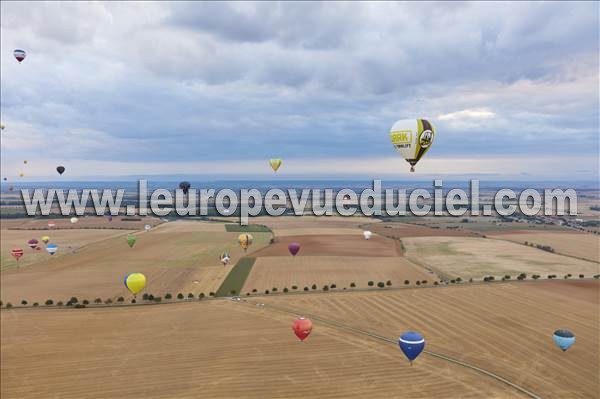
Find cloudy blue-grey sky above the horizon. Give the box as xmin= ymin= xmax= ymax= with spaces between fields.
xmin=0 ymin=2 xmax=599 ymax=180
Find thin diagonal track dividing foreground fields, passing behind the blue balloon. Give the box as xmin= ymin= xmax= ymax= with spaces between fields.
xmin=244 ymin=300 xmax=541 ymax=399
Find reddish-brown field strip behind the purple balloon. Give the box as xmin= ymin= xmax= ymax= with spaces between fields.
xmin=252 ymin=234 xmax=402 ymax=258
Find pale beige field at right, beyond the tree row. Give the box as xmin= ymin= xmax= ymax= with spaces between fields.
xmin=403 ymin=237 xmax=599 ymax=279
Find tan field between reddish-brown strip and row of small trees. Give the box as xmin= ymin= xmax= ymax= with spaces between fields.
xmin=242 ymin=255 xmax=437 ymax=293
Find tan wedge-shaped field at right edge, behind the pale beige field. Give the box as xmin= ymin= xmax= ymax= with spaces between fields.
xmin=491 ymin=232 xmax=600 ymax=262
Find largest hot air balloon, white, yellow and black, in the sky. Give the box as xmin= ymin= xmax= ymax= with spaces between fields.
xmin=390 ymin=119 xmax=435 ymax=172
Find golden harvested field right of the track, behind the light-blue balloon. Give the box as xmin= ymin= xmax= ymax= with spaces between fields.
xmin=261 ymin=280 xmax=600 ymax=398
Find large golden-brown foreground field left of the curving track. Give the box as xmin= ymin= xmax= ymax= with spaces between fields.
xmin=0 ymin=301 xmax=524 ymax=399
